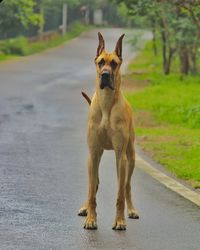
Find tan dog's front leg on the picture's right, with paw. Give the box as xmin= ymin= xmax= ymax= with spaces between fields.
xmin=113 ymin=151 xmax=126 ymax=230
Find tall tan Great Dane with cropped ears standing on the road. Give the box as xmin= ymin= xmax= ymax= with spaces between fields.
xmin=78 ymin=32 xmax=139 ymax=230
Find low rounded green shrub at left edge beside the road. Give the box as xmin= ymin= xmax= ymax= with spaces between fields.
xmin=1 ymin=36 xmax=29 ymax=56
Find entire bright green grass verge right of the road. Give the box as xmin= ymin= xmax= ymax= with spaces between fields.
xmin=126 ymin=42 xmax=200 ymax=188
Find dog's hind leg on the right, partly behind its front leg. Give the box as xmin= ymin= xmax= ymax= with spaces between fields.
xmin=125 ymin=139 xmax=139 ymax=219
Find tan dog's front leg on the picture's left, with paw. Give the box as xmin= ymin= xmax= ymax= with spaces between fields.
xmin=84 ymin=151 xmax=103 ymax=229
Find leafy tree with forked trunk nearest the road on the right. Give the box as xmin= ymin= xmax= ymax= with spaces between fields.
xmin=115 ymin=0 xmax=176 ymax=74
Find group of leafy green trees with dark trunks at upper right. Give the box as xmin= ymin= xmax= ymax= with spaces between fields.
xmin=117 ymin=0 xmax=200 ymax=74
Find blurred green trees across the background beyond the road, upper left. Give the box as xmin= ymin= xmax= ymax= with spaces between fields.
xmin=0 ymin=0 xmax=123 ymax=39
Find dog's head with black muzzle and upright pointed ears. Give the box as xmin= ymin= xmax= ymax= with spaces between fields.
xmin=95 ymin=32 xmax=124 ymax=90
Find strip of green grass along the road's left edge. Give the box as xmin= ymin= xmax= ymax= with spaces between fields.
xmin=0 ymin=22 xmax=91 ymax=61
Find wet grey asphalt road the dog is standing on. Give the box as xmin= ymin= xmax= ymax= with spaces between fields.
xmin=0 ymin=29 xmax=200 ymax=250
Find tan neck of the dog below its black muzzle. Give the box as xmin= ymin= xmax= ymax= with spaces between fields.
xmin=96 ymin=72 xmax=121 ymax=119
